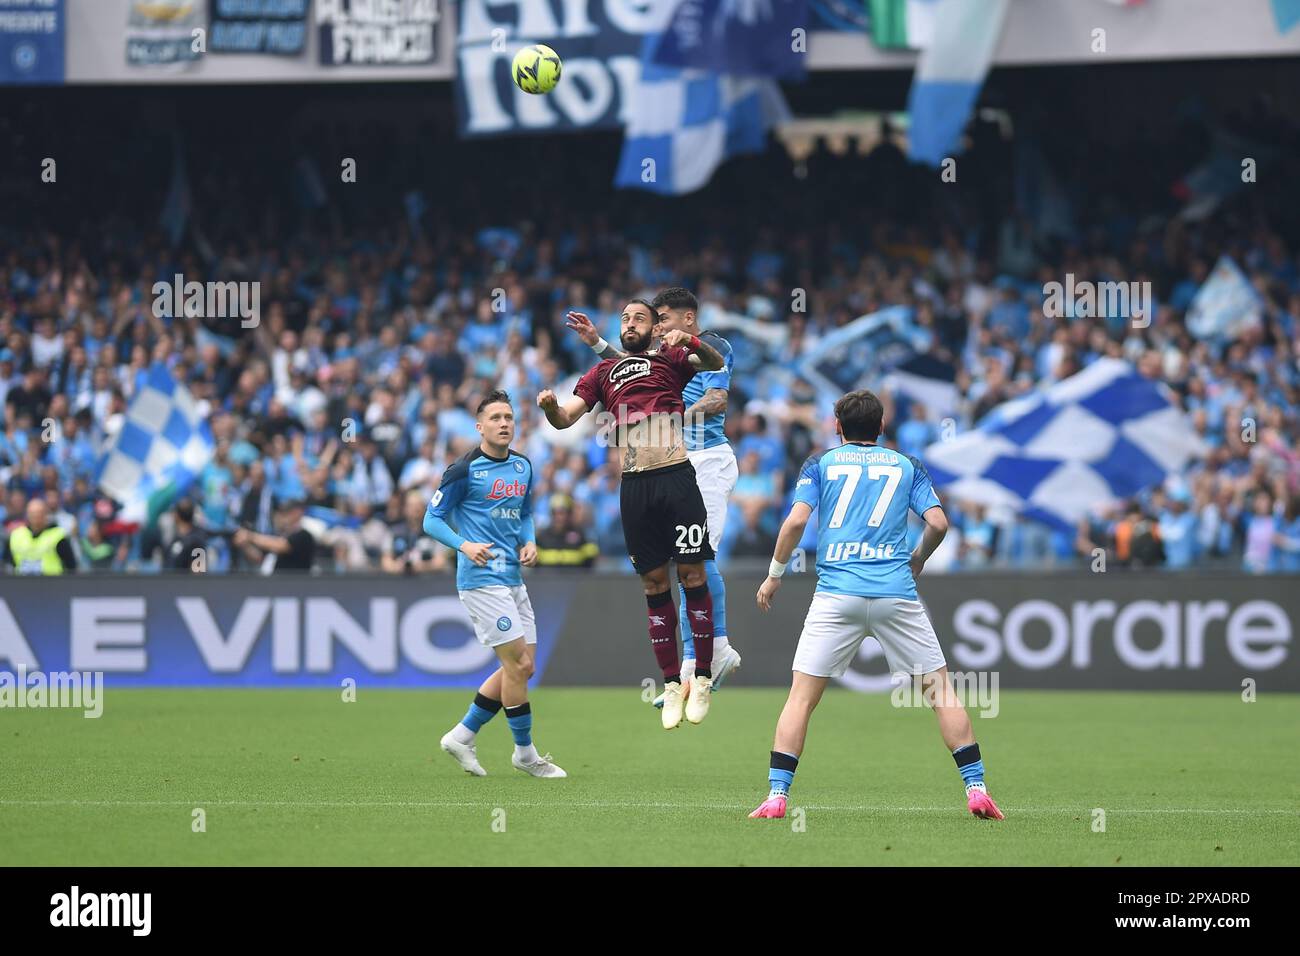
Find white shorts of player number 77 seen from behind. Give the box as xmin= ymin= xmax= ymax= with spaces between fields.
xmin=790 ymin=591 xmax=946 ymax=678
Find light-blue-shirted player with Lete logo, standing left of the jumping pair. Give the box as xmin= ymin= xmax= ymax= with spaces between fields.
xmin=424 ymin=389 xmax=568 ymax=777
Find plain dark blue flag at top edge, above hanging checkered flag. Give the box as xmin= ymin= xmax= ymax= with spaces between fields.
xmin=654 ymin=0 xmax=809 ymax=79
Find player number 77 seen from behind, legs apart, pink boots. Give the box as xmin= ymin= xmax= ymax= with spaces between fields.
xmin=749 ymin=390 xmax=1002 ymax=819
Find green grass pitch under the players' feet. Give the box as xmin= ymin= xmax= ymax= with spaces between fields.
xmin=0 ymin=684 xmax=1300 ymax=866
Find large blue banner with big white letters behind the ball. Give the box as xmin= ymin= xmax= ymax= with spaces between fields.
xmin=456 ymin=0 xmax=650 ymax=137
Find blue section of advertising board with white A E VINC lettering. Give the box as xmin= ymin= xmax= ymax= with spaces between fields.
xmin=0 ymin=575 xmax=579 ymax=687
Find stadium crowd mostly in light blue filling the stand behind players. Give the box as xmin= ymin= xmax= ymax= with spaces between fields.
xmin=0 ymin=89 xmax=1300 ymax=574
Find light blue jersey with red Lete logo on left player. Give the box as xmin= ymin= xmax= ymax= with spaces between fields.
xmin=425 ymin=447 xmax=534 ymax=591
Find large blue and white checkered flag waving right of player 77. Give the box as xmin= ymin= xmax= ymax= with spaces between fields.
xmin=923 ymin=359 xmax=1206 ymax=529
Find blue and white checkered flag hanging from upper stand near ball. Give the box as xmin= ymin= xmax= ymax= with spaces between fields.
xmin=614 ymin=35 xmax=790 ymax=195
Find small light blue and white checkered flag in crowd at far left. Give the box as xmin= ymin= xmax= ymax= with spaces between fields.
xmin=96 ymin=363 xmax=216 ymax=520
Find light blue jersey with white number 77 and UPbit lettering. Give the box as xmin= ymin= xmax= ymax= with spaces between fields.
xmin=794 ymin=442 xmax=939 ymax=601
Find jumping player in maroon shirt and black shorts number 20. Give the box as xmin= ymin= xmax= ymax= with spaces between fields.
xmin=537 ymin=299 xmax=724 ymax=730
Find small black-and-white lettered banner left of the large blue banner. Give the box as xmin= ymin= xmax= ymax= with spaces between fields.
xmin=316 ymin=0 xmax=442 ymax=66
